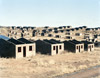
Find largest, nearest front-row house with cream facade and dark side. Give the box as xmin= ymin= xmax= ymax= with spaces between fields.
xmin=0 ymin=39 xmax=35 ymax=58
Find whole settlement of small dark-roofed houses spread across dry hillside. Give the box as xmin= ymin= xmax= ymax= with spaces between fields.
xmin=0 ymin=26 xmax=100 ymax=58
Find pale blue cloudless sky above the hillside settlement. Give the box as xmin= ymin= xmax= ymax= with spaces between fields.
xmin=0 ymin=0 xmax=100 ymax=27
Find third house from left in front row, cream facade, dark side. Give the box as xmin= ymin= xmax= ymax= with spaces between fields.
xmin=63 ymin=40 xmax=84 ymax=53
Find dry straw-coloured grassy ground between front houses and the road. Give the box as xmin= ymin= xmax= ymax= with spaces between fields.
xmin=0 ymin=48 xmax=100 ymax=78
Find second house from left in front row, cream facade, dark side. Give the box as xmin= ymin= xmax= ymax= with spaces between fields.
xmin=36 ymin=40 xmax=64 ymax=55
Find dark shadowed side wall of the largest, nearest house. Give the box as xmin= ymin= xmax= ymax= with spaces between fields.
xmin=0 ymin=40 xmax=15 ymax=57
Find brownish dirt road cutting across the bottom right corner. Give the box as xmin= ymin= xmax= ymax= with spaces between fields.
xmin=54 ymin=65 xmax=100 ymax=78
